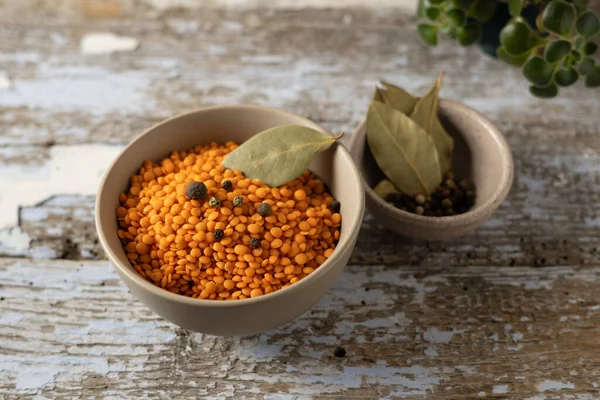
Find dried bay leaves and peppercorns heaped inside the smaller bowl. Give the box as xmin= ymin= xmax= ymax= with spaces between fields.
xmin=366 ymin=73 xmax=474 ymax=216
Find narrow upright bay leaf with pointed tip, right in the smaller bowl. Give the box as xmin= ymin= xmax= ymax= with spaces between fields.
xmin=410 ymin=74 xmax=454 ymax=175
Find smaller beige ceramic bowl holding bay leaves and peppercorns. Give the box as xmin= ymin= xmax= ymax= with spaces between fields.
xmin=349 ymin=100 xmax=513 ymax=240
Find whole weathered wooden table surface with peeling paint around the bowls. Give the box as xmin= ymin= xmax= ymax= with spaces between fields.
xmin=0 ymin=0 xmax=600 ymax=400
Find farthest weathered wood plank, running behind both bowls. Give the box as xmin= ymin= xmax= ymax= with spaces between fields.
xmin=0 ymin=5 xmax=598 ymax=145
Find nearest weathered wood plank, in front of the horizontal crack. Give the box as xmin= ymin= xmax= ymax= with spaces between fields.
xmin=0 ymin=259 xmax=600 ymax=399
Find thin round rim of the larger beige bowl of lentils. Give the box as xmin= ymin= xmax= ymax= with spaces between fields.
xmin=94 ymin=104 xmax=365 ymax=308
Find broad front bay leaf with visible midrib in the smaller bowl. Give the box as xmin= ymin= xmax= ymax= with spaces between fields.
xmin=367 ymin=102 xmax=442 ymax=195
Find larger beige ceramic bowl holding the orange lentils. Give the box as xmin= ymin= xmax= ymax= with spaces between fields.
xmin=96 ymin=105 xmax=364 ymax=335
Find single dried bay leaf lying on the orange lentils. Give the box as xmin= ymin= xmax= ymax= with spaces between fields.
xmin=222 ymin=125 xmax=342 ymax=187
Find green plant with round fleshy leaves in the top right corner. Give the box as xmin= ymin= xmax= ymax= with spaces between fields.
xmin=417 ymin=0 xmax=600 ymax=98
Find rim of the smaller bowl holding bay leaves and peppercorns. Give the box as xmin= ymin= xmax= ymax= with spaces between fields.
xmin=349 ymin=99 xmax=514 ymax=227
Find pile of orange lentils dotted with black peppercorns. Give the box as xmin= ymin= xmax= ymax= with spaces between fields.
xmin=116 ymin=143 xmax=342 ymax=300
